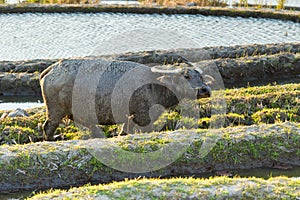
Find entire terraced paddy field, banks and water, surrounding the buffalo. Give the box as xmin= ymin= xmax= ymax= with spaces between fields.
xmin=0 ymin=4 xmax=300 ymax=195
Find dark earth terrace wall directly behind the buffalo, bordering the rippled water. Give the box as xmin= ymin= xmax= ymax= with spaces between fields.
xmin=0 ymin=43 xmax=300 ymax=96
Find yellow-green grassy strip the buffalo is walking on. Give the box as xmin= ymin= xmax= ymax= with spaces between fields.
xmin=0 ymin=84 xmax=300 ymax=144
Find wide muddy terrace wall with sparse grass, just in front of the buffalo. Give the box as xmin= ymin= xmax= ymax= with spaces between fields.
xmin=0 ymin=122 xmax=300 ymax=193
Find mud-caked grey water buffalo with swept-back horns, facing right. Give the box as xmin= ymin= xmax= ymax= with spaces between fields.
xmin=40 ymin=58 xmax=211 ymax=140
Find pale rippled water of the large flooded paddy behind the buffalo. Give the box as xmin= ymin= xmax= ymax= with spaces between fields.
xmin=0 ymin=13 xmax=300 ymax=60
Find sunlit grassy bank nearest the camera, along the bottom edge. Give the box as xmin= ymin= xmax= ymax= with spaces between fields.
xmin=30 ymin=177 xmax=300 ymax=200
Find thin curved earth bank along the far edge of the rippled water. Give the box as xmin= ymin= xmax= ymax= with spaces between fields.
xmin=0 ymin=4 xmax=300 ymax=22
